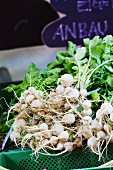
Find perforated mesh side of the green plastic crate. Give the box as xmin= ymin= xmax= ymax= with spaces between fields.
xmin=19 ymin=145 xmax=113 ymax=170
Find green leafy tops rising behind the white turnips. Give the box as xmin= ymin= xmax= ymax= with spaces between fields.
xmin=7 ymin=35 xmax=113 ymax=98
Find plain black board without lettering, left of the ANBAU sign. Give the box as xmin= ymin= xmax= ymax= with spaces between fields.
xmin=0 ymin=0 xmax=58 ymax=50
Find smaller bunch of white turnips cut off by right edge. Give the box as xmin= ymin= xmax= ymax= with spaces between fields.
xmin=87 ymin=102 xmax=113 ymax=159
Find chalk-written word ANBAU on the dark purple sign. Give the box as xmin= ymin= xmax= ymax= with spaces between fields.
xmin=53 ymin=20 xmax=108 ymax=41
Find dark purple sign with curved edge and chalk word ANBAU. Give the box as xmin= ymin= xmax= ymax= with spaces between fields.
xmin=43 ymin=0 xmax=113 ymax=47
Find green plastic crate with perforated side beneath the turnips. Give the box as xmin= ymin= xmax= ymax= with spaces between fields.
xmin=0 ymin=145 xmax=113 ymax=170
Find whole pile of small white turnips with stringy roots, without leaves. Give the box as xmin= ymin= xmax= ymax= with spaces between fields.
xmin=8 ymin=74 xmax=113 ymax=158
